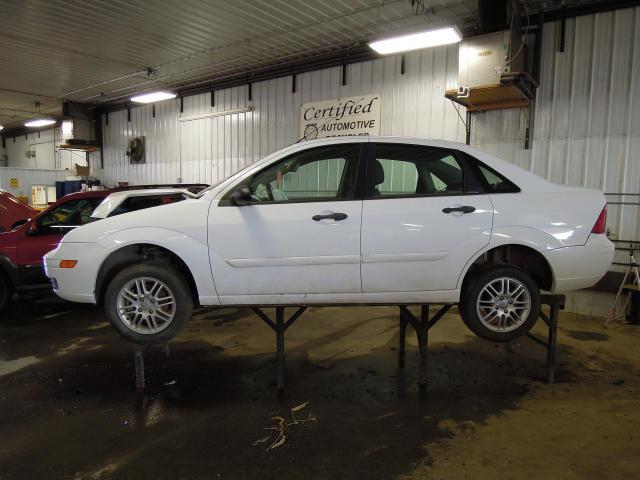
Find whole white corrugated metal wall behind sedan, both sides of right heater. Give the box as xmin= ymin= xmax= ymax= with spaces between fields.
xmin=95 ymin=8 xmax=640 ymax=248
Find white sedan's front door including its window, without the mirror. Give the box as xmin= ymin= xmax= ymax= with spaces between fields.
xmin=209 ymin=140 xmax=364 ymax=304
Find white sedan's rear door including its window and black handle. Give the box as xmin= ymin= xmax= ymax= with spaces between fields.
xmin=362 ymin=143 xmax=493 ymax=293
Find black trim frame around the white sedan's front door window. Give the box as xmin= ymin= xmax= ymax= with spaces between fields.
xmin=218 ymin=144 xmax=369 ymax=208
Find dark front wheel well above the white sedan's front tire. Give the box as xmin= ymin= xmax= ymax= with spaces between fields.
xmin=95 ymin=242 xmax=199 ymax=305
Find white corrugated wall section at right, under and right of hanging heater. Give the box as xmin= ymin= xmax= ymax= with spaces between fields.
xmin=472 ymin=8 xmax=640 ymax=246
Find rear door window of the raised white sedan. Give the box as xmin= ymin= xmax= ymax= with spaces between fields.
xmin=367 ymin=144 xmax=464 ymax=197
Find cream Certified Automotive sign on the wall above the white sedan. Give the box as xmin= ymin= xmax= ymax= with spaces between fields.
xmin=300 ymin=95 xmax=380 ymax=140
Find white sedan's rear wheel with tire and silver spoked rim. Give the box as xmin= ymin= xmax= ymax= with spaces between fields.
xmin=458 ymin=266 xmax=540 ymax=342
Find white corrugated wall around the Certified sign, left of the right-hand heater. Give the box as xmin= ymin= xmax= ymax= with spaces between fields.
xmin=103 ymin=41 xmax=464 ymax=183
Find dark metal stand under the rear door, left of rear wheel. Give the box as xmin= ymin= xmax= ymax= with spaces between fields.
xmin=398 ymin=305 xmax=452 ymax=387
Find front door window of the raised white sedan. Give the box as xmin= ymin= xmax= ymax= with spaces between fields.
xmin=248 ymin=143 xmax=361 ymax=203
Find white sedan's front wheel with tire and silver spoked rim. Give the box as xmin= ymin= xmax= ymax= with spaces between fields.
xmin=104 ymin=263 xmax=193 ymax=345
